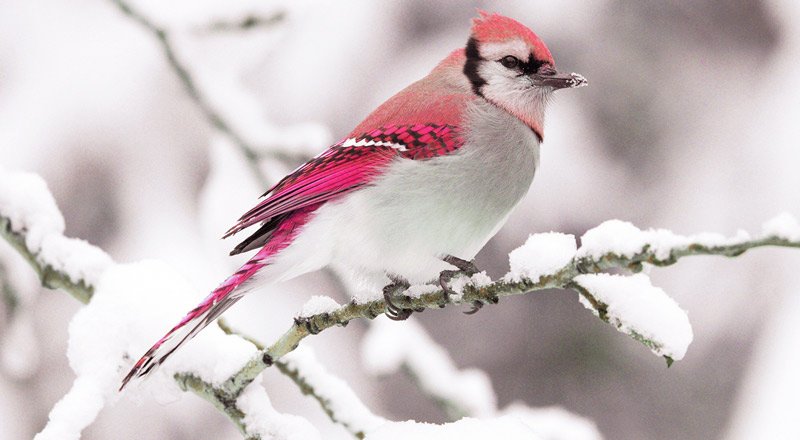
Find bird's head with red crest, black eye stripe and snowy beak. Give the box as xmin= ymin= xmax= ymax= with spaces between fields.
xmin=464 ymin=11 xmax=586 ymax=140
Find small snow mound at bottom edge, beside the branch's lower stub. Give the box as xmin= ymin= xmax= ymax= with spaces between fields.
xmin=236 ymin=376 xmax=321 ymax=440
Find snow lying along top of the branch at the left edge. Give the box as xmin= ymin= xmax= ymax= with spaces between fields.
xmin=0 ymin=170 xmax=112 ymax=285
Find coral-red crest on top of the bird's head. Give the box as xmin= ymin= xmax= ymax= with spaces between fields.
xmin=472 ymin=9 xmax=553 ymax=64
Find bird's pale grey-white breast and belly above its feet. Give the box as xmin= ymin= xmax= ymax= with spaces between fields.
xmin=265 ymin=100 xmax=538 ymax=289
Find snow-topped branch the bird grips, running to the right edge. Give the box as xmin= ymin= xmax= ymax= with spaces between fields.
xmin=225 ymin=218 xmax=800 ymax=395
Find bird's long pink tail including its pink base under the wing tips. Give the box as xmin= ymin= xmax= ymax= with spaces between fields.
xmin=119 ymin=204 xmax=320 ymax=391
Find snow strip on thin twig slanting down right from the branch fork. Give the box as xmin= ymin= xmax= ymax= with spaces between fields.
xmin=281 ymin=346 xmax=386 ymax=432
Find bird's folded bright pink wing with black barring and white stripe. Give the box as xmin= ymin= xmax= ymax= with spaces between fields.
xmin=225 ymin=123 xmax=463 ymax=253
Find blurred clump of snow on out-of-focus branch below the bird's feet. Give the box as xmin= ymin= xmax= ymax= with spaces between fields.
xmin=361 ymin=316 xmax=497 ymax=417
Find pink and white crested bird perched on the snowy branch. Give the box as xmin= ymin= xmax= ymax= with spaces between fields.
xmin=120 ymin=11 xmax=587 ymax=390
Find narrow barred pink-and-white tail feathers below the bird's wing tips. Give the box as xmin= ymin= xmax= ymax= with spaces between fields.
xmin=119 ymin=252 xmax=267 ymax=391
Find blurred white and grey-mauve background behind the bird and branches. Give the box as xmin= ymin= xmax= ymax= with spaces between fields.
xmin=0 ymin=0 xmax=800 ymax=439
